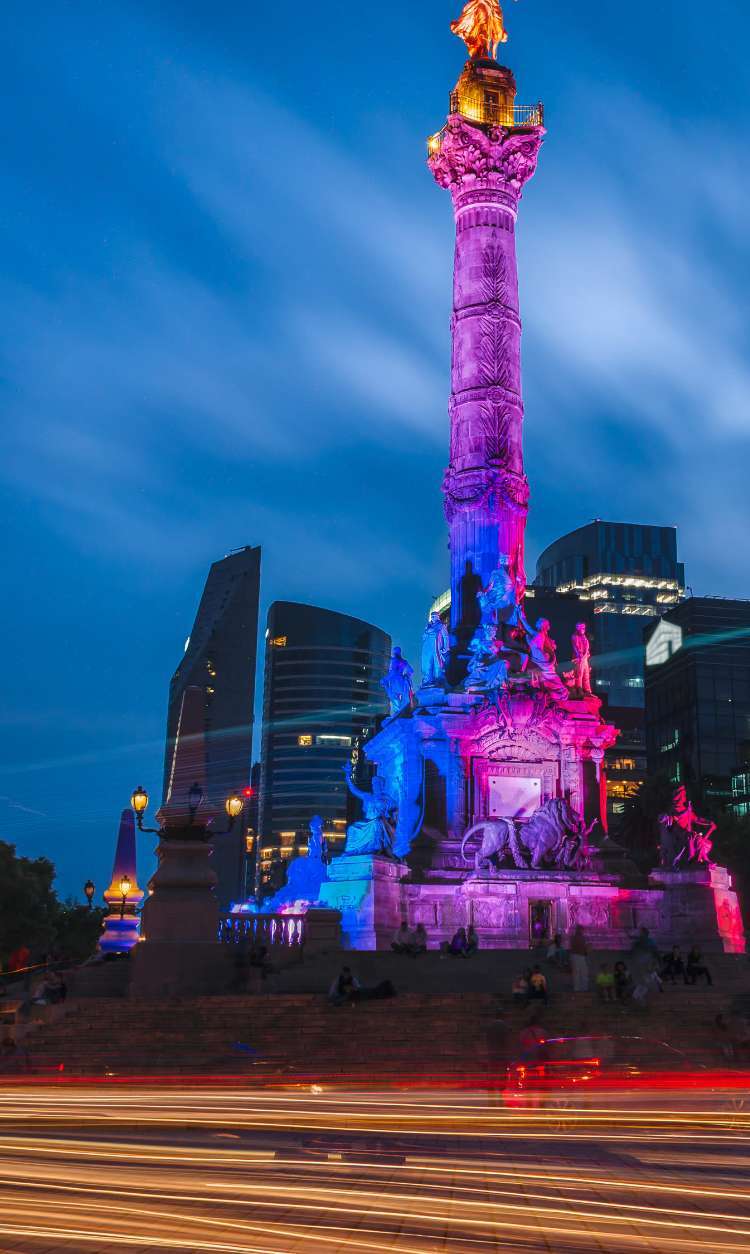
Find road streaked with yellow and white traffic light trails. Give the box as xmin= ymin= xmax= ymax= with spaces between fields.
xmin=0 ymin=1083 xmax=750 ymax=1254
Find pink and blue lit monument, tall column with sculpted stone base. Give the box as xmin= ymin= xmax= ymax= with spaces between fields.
xmin=298 ymin=36 xmax=745 ymax=952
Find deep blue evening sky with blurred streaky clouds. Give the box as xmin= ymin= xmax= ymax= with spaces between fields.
xmin=0 ymin=0 xmax=750 ymax=892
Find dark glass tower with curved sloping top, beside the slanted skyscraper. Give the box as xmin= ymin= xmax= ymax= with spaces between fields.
xmin=257 ymin=601 xmax=390 ymax=893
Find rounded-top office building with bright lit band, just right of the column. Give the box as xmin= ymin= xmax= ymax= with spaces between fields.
xmin=534 ymin=520 xmax=685 ymax=715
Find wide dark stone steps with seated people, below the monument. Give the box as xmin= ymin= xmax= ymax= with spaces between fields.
xmin=10 ymin=952 xmax=750 ymax=1083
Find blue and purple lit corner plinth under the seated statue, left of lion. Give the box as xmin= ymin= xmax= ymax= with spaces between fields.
xmin=320 ymin=854 xmax=409 ymax=949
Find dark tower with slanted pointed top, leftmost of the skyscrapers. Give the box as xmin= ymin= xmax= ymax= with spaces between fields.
xmin=163 ymin=548 xmax=261 ymax=909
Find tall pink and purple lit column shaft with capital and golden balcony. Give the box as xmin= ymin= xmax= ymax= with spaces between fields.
xmin=429 ymin=60 xmax=546 ymax=653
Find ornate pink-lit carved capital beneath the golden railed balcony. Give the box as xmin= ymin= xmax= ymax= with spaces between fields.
xmin=429 ymin=113 xmax=546 ymax=199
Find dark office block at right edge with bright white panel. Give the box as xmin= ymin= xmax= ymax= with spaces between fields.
xmin=646 ymin=597 xmax=750 ymax=813
